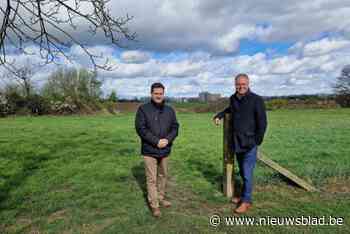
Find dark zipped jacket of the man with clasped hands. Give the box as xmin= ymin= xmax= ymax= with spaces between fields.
xmin=135 ymin=101 xmax=179 ymax=157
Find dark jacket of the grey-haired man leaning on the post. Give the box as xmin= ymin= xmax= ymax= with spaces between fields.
xmin=214 ymin=90 xmax=267 ymax=153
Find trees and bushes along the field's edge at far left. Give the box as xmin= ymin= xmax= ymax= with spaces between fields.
xmin=0 ymin=67 xmax=117 ymax=116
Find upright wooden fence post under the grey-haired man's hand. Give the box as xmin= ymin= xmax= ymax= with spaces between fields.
xmin=223 ymin=114 xmax=234 ymax=198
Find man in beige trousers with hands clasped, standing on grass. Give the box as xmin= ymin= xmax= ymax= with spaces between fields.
xmin=135 ymin=83 xmax=179 ymax=217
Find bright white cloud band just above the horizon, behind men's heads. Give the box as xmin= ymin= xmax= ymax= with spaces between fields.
xmin=97 ymin=46 xmax=350 ymax=96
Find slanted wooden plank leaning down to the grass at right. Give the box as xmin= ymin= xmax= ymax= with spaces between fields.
xmin=258 ymin=151 xmax=318 ymax=192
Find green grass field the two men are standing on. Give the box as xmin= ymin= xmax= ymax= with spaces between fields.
xmin=0 ymin=109 xmax=350 ymax=233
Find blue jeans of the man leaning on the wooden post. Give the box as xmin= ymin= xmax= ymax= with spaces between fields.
xmin=236 ymin=146 xmax=258 ymax=202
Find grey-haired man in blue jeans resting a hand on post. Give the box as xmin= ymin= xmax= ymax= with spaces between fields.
xmin=214 ymin=74 xmax=267 ymax=213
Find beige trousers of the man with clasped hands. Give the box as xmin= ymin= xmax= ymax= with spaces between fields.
xmin=143 ymin=155 xmax=168 ymax=208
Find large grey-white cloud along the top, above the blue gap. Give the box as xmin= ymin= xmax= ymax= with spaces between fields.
xmin=106 ymin=0 xmax=350 ymax=53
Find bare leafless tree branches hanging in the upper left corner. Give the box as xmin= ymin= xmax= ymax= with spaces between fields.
xmin=0 ymin=0 xmax=136 ymax=75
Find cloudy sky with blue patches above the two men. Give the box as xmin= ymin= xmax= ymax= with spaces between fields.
xmin=2 ymin=0 xmax=350 ymax=97
